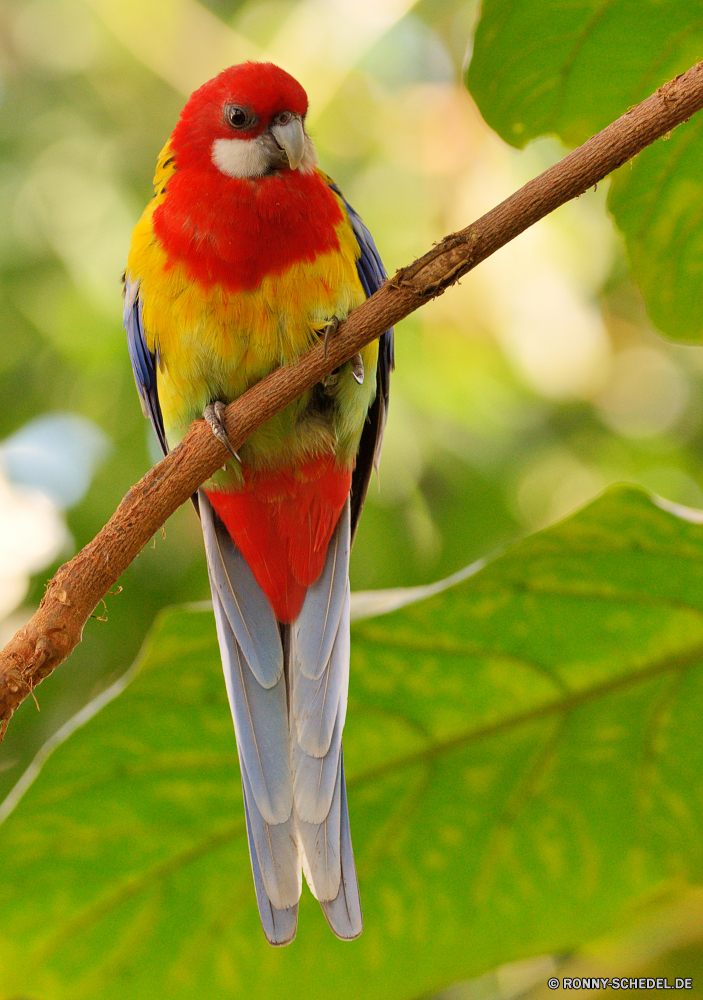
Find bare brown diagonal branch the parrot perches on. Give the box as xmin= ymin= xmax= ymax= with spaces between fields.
xmin=0 ymin=63 xmax=703 ymax=736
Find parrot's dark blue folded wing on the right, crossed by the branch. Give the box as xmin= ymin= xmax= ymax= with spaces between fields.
xmin=330 ymin=182 xmax=395 ymax=538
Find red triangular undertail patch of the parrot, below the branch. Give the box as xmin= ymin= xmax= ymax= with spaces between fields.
xmin=206 ymin=456 xmax=352 ymax=623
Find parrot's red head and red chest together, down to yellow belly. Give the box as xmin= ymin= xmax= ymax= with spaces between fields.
xmin=153 ymin=63 xmax=343 ymax=290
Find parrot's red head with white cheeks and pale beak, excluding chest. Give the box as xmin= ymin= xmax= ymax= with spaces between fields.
xmin=171 ymin=62 xmax=317 ymax=177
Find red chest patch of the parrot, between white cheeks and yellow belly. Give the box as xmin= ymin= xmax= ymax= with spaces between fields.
xmin=154 ymin=170 xmax=343 ymax=291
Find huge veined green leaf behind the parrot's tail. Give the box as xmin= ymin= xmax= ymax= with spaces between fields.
xmin=0 ymin=487 xmax=703 ymax=1000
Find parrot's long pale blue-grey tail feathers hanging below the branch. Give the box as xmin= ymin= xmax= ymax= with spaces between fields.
xmin=199 ymin=490 xmax=362 ymax=945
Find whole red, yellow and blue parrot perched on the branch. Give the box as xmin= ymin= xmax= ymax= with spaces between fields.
xmin=123 ymin=62 xmax=394 ymax=945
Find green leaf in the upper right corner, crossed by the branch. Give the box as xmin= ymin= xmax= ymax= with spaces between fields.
xmin=468 ymin=0 xmax=703 ymax=343
